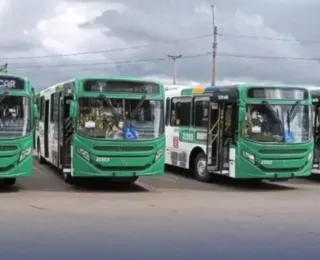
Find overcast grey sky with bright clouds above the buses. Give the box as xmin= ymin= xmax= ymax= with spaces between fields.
xmin=0 ymin=0 xmax=320 ymax=89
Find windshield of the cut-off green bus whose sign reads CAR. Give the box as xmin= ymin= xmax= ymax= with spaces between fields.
xmin=0 ymin=94 xmax=31 ymax=139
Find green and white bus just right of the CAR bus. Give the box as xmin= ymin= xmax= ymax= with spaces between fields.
xmin=37 ymin=77 xmax=165 ymax=183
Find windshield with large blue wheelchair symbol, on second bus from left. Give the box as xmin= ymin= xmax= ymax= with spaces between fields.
xmin=77 ymin=96 xmax=164 ymax=140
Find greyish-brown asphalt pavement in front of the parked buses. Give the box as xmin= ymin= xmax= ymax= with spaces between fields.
xmin=0 ymin=160 xmax=320 ymax=260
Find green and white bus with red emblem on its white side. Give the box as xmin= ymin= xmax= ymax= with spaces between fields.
xmin=165 ymin=84 xmax=314 ymax=181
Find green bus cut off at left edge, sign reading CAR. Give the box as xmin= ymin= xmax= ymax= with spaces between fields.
xmin=0 ymin=73 xmax=38 ymax=186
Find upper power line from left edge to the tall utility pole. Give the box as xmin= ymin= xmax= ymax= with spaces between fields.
xmin=0 ymin=34 xmax=212 ymax=60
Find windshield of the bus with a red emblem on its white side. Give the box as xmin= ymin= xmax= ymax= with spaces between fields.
xmin=243 ymin=103 xmax=312 ymax=143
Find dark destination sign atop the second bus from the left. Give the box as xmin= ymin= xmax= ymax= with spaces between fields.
xmin=83 ymin=80 xmax=160 ymax=94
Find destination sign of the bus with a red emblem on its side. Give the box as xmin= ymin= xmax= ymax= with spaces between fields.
xmin=248 ymin=87 xmax=308 ymax=100
